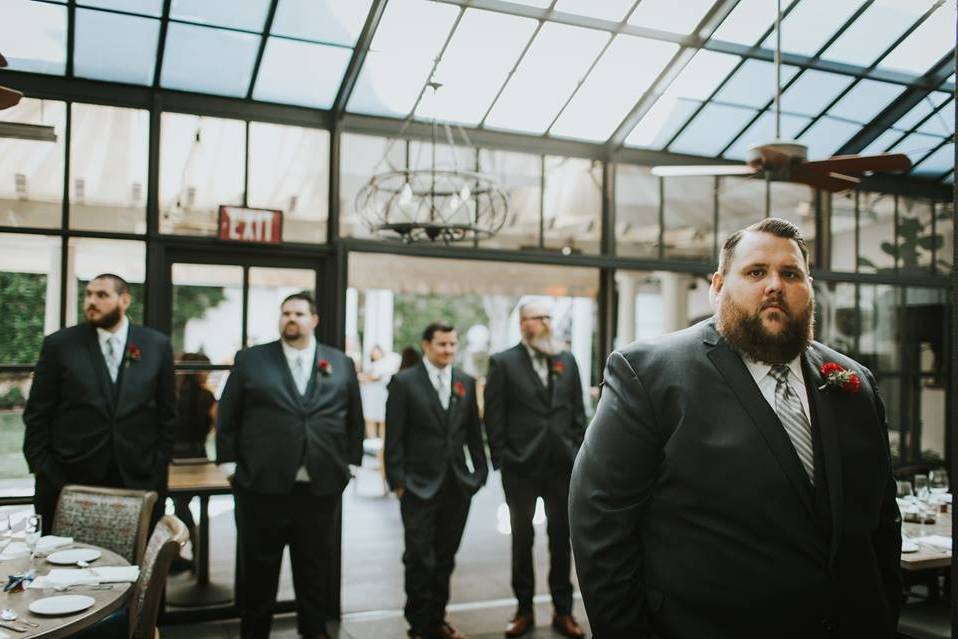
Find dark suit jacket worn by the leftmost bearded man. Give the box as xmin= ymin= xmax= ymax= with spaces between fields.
xmin=23 ymin=323 xmax=176 ymax=491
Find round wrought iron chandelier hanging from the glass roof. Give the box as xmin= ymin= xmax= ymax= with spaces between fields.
xmin=356 ymin=81 xmax=508 ymax=243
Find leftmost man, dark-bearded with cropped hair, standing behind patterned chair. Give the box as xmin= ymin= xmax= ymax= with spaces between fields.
xmin=23 ymin=273 xmax=176 ymax=533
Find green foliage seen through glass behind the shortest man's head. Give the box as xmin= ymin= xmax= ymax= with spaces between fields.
xmin=393 ymin=293 xmax=489 ymax=352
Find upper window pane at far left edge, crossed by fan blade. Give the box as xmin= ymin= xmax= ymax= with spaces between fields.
xmin=0 ymin=98 xmax=66 ymax=228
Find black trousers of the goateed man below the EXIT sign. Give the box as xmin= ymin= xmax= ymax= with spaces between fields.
xmin=233 ymin=482 xmax=340 ymax=639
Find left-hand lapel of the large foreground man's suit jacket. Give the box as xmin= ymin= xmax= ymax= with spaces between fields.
xmin=708 ymin=326 xmax=815 ymax=517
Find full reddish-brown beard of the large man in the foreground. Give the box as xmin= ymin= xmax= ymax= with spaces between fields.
xmin=718 ymin=297 xmax=815 ymax=364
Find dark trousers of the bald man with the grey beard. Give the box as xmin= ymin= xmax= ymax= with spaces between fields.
xmin=502 ymin=469 xmax=572 ymax=614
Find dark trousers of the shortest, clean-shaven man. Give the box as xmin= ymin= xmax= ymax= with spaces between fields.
xmin=400 ymin=471 xmax=472 ymax=637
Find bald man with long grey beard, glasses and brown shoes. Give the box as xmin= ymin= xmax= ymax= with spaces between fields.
xmin=485 ymin=301 xmax=585 ymax=638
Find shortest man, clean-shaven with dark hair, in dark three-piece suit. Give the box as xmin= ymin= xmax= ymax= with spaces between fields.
xmin=385 ymin=323 xmax=488 ymax=639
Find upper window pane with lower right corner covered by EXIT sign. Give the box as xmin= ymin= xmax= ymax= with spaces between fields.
xmin=160 ymin=113 xmax=246 ymax=235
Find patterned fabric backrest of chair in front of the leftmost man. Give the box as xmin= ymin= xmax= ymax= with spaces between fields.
xmin=53 ymin=486 xmax=157 ymax=564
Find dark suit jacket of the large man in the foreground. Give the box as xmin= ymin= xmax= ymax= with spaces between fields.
xmin=570 ymin=320 xmax=902 ymax=639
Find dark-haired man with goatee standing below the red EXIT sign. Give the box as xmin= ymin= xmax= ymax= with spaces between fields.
xmin=216 ymin=293 xmax=363 ymax=639
